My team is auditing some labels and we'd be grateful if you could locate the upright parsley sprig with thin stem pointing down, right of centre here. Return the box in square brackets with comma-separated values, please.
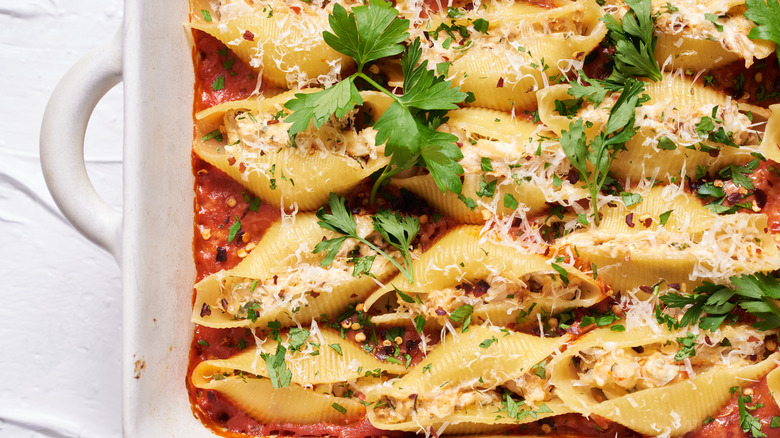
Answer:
[560, 78, 649, 225]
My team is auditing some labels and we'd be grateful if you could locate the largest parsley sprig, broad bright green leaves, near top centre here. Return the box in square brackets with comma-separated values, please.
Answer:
[285, 0, 468, 202]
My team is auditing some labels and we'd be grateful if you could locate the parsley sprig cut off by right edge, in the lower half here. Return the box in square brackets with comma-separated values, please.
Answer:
[661, 272, 780, 331]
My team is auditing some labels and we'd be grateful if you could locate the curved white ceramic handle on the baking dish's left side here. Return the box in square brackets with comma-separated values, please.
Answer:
[40, 31, 122, 257]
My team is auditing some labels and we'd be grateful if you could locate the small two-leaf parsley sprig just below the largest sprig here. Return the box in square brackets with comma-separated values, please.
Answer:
[314, 193, 420, 283]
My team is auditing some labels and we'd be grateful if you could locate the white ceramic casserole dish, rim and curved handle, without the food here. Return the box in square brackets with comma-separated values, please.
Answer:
[40, 0, 214, 438]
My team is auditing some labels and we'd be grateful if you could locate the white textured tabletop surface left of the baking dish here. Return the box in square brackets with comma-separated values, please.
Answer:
[0, 0, 122, 438]
